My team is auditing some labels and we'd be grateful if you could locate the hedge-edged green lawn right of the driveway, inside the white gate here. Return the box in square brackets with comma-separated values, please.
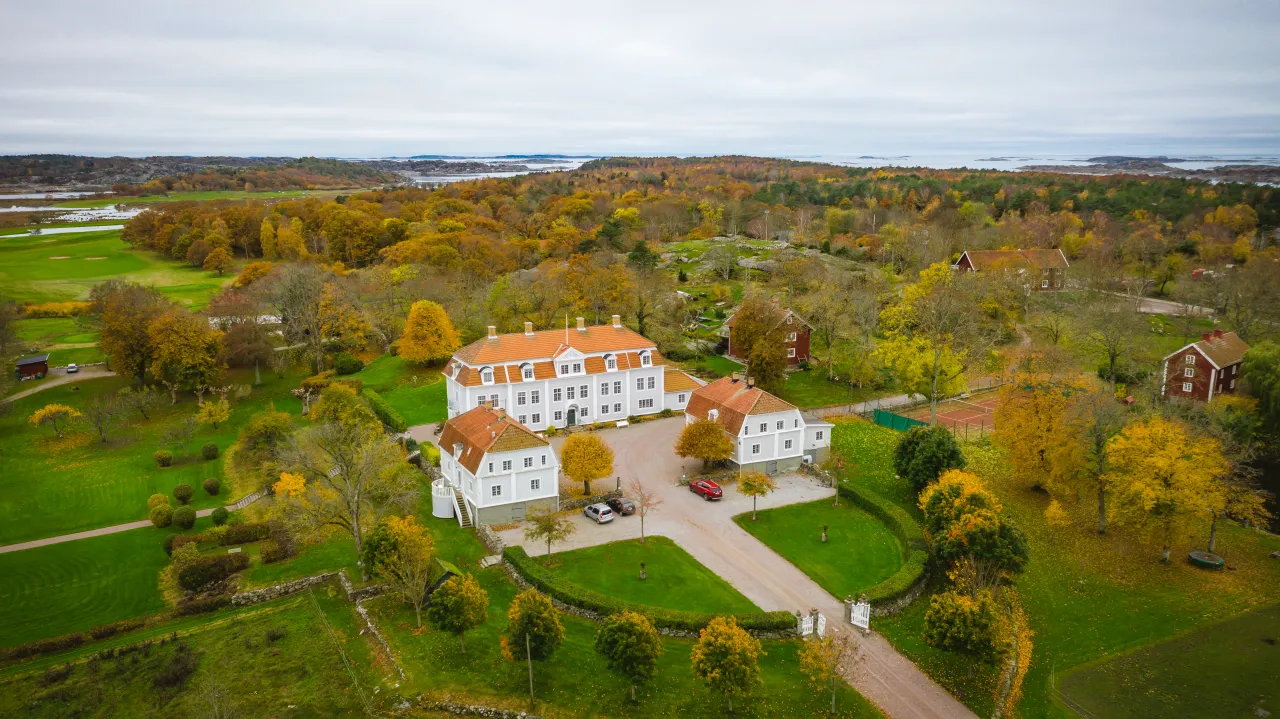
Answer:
[733, 499, 902, 597]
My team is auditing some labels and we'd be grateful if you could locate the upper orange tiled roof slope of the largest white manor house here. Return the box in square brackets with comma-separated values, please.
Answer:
[453, 325, 655, 366]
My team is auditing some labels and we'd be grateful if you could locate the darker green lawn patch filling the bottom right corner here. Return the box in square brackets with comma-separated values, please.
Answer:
[1059, 598, 1280, 719]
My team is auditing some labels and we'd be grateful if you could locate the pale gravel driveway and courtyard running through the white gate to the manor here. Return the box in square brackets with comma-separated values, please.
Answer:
[483, 417, 974, 719]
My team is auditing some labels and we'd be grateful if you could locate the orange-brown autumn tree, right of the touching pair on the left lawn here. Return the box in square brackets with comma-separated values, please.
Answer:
[147, 307, 225, 404]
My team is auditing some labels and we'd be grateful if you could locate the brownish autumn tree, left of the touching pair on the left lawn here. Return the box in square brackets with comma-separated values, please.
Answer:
[90, 280, 172, 386]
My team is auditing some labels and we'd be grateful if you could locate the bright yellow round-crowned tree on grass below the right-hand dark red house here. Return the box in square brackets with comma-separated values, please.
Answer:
[1108, 417, 1228, 564]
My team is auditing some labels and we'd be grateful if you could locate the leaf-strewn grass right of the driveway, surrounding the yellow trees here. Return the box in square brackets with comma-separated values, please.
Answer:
[833, 421, 1280, 716]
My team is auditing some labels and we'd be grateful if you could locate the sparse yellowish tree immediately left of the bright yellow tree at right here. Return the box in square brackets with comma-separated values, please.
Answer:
[1050, 391, 1125, 535]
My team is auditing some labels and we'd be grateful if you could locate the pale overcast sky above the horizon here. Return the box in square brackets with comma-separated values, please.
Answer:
[0, 0, 1280, 156]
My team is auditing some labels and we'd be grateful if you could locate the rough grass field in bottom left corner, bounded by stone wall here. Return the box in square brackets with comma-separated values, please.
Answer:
[0, 587, 379, 719]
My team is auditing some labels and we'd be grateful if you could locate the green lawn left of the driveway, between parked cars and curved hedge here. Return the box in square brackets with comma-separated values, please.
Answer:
[542, 537, 760, 614]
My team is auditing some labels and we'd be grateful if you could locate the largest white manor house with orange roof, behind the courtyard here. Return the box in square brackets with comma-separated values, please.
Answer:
[444, 315, 699, 432]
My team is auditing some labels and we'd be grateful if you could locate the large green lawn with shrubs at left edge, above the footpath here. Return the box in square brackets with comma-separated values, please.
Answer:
[0, 370, 301, 544]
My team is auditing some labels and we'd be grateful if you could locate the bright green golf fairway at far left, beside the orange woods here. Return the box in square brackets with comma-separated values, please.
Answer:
[0, 230, 232, 303]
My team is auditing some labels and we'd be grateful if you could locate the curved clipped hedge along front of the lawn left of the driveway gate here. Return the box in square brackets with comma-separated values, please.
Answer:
[503, 546, 796, 632]
